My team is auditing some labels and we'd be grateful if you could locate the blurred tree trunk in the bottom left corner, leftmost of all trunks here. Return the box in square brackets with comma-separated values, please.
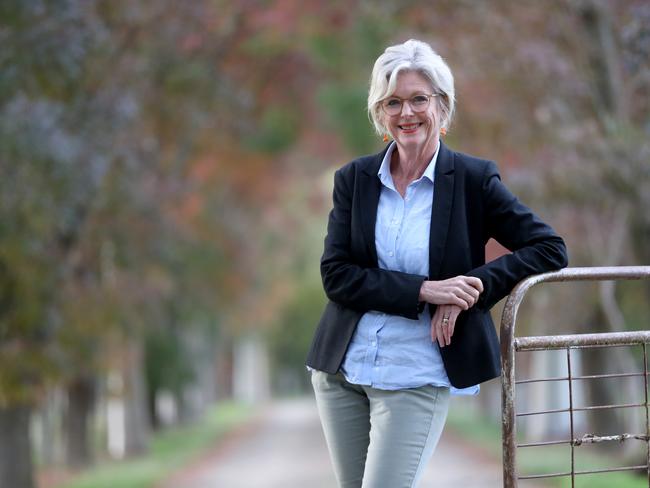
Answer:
[0, 405, 34, 488]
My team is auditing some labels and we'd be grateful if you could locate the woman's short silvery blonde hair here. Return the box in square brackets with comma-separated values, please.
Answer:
[368, 39, 456, 135]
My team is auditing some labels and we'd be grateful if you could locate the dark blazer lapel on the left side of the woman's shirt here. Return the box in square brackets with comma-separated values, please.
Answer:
[359, 144, 390, 266]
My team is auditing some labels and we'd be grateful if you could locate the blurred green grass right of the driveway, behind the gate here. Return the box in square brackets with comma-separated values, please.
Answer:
[447, 399, 648, 488]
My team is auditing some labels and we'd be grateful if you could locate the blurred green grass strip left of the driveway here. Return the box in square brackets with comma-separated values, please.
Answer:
[59, 403, 252, 488]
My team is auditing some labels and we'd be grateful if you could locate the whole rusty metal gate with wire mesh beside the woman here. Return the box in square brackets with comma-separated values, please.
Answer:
[501, 266, 650, 488]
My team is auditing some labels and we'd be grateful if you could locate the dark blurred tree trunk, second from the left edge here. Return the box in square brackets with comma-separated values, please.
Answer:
[65, 376, 95, 468]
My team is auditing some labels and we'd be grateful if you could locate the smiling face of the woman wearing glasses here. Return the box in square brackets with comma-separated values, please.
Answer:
[382, 71, 440, 151]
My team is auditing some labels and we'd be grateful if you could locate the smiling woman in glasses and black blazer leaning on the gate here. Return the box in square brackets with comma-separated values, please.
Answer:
[307, 40, 567, 488]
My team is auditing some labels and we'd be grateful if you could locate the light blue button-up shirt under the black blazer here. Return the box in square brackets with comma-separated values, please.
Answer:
[341, 143, 478, 394]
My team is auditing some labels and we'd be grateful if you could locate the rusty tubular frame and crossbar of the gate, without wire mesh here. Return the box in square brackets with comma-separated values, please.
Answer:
[500, 266, 650, 488]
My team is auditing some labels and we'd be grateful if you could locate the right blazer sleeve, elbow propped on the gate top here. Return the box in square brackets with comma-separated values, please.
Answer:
[466, 161, 568, 310]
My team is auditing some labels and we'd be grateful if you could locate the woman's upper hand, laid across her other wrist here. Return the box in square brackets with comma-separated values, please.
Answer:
[420, 275, 483, 310]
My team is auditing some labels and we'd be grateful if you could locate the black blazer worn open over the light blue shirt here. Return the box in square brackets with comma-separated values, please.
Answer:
[307, 142, 567, 388]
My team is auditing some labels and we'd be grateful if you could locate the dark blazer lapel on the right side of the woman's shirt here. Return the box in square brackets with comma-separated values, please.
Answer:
[429, 141, 454, 280]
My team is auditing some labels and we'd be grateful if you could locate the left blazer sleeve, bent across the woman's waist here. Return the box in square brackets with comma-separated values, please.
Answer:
[321, 166, 427, 319]
